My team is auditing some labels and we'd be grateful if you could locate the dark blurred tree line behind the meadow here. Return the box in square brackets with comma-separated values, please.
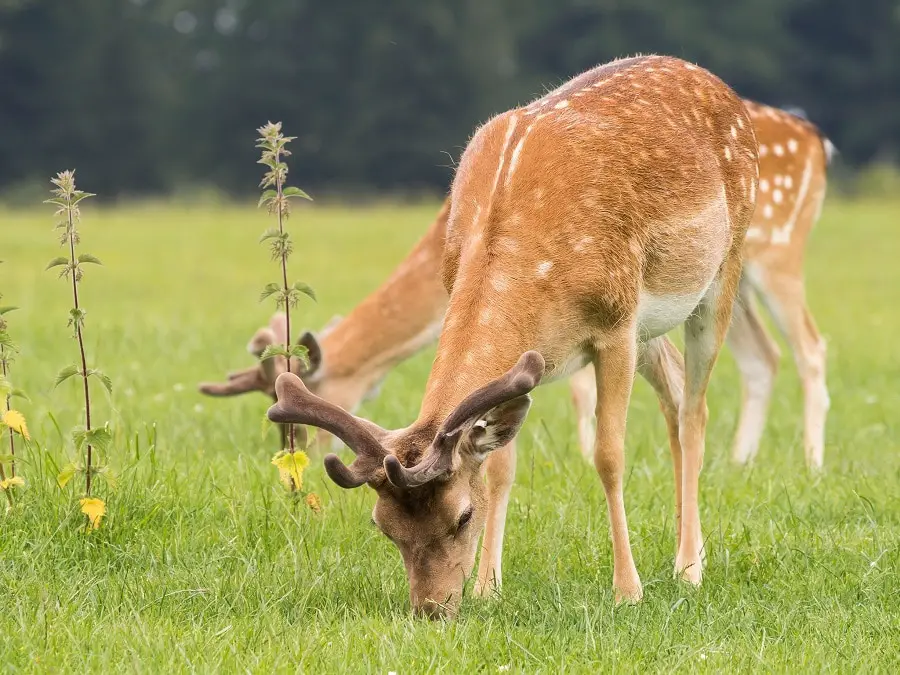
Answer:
[0, 0, 900, 195]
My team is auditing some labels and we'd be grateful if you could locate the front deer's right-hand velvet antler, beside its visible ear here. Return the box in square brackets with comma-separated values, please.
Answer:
[384, 351, 544, 489]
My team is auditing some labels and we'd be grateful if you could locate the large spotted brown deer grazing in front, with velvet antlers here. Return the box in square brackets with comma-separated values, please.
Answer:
[268, 56, 758, 616]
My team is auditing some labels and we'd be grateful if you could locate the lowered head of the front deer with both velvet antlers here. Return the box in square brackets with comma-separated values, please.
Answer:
[268, 351, 544, 617]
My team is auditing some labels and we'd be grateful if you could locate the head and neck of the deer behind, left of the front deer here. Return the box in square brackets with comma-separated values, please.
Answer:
[200, 202, 450, 447]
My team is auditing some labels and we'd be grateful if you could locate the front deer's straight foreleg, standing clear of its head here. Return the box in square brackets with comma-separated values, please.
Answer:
[594, 332, 643, 603]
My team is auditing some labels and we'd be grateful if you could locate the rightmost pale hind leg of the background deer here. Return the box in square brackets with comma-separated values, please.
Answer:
[763, 275, 829, 470]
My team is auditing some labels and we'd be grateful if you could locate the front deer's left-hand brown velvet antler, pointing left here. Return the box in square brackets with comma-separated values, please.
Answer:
[268, 373, 388, 488]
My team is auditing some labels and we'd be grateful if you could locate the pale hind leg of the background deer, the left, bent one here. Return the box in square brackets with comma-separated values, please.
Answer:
[728, 280, 781, 464]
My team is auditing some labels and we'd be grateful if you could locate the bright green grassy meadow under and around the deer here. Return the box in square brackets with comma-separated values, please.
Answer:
[0, 202, 900, 673]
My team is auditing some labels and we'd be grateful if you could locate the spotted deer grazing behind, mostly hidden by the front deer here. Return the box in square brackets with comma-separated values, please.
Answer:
[201, 100, 832, 467]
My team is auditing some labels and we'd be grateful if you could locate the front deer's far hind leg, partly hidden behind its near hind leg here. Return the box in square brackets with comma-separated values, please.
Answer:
[637, 335, 684, 552]
